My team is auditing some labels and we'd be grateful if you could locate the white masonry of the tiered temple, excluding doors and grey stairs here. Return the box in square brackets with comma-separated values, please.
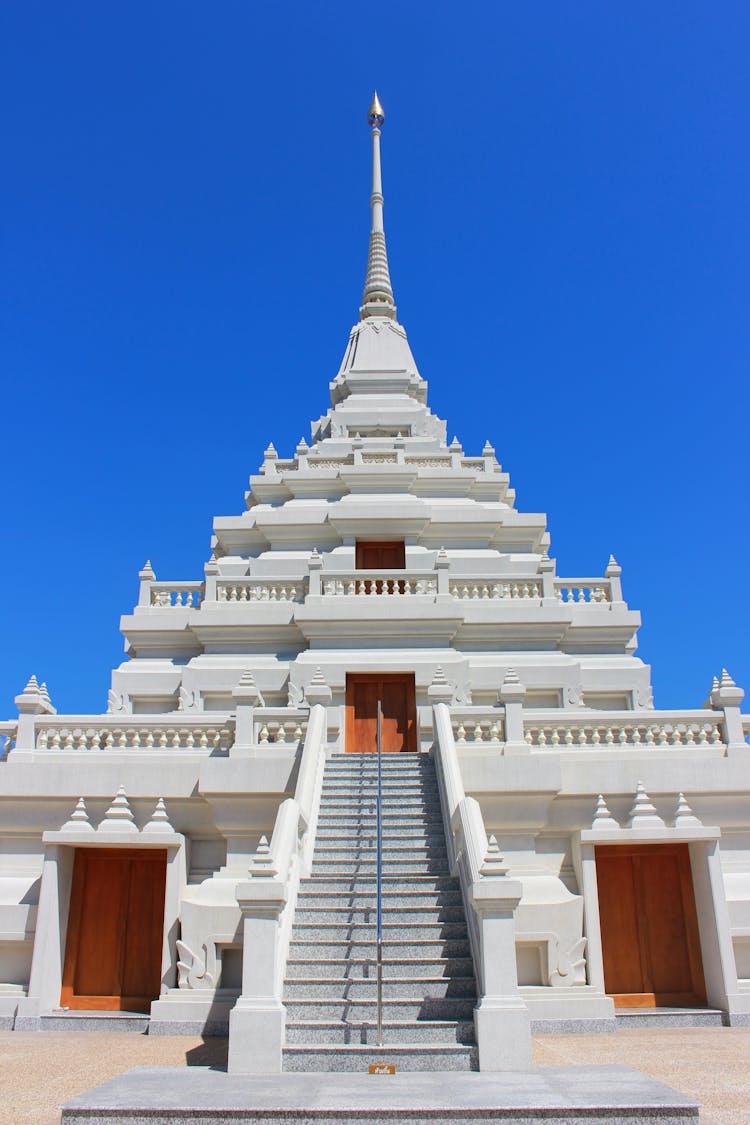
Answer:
[0, 99, 750, 1072]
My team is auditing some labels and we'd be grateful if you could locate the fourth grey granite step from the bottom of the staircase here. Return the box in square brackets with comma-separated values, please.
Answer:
[284, 977, 477, 1005]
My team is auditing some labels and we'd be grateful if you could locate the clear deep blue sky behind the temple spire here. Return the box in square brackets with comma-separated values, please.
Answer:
[0, 0, 750, 718]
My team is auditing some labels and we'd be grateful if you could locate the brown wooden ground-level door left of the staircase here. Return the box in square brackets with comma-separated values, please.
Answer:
[60, 848, 166, 1011]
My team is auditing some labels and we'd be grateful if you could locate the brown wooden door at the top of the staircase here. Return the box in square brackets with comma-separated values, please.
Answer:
[346, 672, 417, 754]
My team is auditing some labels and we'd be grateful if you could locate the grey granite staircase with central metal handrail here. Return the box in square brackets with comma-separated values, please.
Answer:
[283, 754, 477, 1071]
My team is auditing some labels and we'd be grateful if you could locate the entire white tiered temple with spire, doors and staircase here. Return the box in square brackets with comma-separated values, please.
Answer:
[0, 99, 750, 1073]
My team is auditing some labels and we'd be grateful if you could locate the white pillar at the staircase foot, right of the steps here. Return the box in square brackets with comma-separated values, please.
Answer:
[471, 875, 531, 1071]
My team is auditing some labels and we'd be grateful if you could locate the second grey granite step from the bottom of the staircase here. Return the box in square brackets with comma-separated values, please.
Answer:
[287, 1019, 476, 1046]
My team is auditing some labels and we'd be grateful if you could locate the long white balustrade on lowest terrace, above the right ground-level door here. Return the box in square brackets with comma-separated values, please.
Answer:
[523, 711, 724, 750]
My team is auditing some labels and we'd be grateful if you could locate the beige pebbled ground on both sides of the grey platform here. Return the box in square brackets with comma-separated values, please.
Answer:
[0, 1027, 750, 1125]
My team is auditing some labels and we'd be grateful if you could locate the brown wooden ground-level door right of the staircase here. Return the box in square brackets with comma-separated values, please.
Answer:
[596, 844, 706, 1008]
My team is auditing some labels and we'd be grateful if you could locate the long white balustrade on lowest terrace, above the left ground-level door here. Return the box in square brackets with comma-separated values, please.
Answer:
[36, 713, 234, 754]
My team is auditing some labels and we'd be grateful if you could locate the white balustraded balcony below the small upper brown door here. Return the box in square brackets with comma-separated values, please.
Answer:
[123, 551, 640, 655]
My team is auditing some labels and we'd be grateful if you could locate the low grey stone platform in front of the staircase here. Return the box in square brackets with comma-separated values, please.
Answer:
[62, 1067, 698, 1125]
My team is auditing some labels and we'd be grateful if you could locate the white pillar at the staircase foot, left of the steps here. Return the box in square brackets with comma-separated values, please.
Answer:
[227, 878, 287, 1074]
